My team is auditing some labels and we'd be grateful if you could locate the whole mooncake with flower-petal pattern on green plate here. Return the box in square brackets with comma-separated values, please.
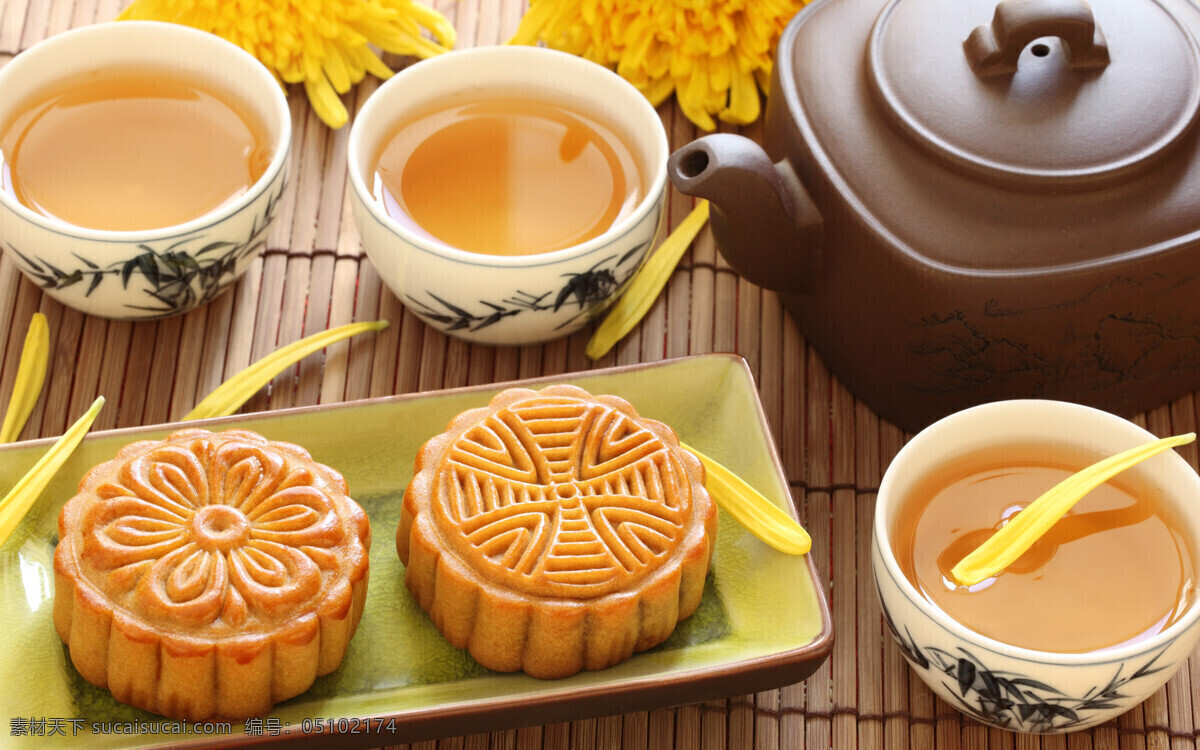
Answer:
[54, 430, 371, 721]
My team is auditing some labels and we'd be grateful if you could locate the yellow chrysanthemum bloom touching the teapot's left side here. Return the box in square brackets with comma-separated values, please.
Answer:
[510, 0, 808, 131]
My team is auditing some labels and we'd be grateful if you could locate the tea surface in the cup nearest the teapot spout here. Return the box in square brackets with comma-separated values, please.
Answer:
[373, 97, 644, 256]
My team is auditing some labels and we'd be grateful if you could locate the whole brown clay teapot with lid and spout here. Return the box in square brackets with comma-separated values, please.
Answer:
[668, 0, 1200, 430]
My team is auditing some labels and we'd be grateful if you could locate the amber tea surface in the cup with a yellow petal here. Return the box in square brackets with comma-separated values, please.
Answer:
[893, 453, 1195, 653]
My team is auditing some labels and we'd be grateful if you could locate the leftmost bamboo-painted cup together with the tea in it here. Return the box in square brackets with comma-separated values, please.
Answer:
[0, 22, 292, 319]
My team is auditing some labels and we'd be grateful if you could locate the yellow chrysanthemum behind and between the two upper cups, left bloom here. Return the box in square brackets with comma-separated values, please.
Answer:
[118, 0, 456, 128]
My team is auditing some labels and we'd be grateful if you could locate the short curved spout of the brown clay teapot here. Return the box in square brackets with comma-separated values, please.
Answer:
[667, 133, 822, 293]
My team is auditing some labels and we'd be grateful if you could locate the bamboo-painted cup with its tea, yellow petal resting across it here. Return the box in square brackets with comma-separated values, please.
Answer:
[871, 400, 1200, 733]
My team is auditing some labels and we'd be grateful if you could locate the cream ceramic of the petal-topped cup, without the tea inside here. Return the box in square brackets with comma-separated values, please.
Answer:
[871, 400, 1200, 734]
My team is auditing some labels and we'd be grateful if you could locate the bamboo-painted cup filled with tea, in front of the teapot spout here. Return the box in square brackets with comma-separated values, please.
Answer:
[349, 46, 667, 344]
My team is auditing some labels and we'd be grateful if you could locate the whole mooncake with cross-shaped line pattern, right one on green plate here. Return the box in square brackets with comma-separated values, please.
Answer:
[396, 385, 716, 678]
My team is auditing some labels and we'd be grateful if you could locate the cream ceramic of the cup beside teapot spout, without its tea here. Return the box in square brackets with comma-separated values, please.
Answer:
[349, 46, 667, 344]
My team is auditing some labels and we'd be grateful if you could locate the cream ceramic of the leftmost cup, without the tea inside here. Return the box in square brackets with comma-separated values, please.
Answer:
[0, 20, 292, 319]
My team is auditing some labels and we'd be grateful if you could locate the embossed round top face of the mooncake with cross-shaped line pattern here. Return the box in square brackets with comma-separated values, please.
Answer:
[432, 397, 691, 599]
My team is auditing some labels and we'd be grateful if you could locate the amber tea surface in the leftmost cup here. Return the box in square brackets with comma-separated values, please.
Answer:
[0, 71, 271, 232]
